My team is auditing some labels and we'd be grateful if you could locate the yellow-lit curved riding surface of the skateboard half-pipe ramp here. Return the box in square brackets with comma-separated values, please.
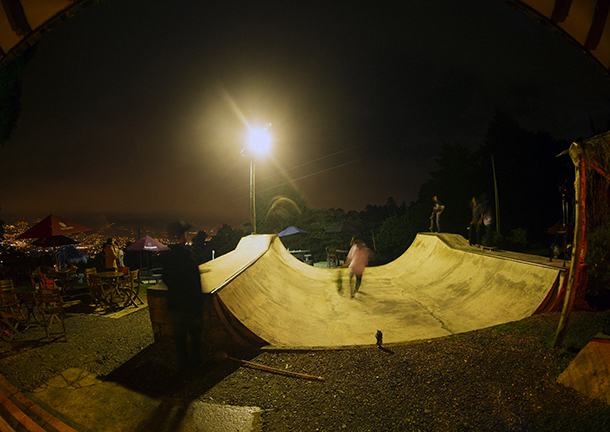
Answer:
[202, 233, 563, 347]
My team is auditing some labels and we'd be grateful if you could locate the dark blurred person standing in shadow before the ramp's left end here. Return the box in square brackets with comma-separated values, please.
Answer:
[162, 223, 203, 372]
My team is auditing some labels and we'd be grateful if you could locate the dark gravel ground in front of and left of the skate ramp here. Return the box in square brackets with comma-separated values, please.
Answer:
[0, 292, 610, 431]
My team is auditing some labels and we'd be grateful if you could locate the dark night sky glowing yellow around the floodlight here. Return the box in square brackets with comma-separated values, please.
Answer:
[0, 0, 610, 236]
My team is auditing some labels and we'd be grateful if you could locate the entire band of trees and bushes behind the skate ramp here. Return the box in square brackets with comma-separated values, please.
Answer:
[208, 112, 573, 264]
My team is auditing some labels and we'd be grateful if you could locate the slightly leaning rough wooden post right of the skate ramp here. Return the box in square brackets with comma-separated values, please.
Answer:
[553, 143, 587, 348]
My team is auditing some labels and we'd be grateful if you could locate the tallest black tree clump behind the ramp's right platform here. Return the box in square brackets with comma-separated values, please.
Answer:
[417, 111, 572, 246]
